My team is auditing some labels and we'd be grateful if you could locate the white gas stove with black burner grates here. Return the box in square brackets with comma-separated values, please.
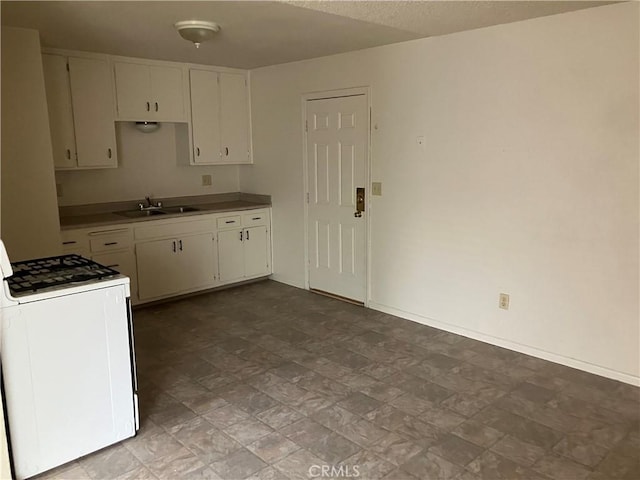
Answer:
[0, 240, 139, 480]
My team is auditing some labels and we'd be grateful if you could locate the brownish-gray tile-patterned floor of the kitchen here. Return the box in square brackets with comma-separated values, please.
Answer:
[41, 281, 640, 480]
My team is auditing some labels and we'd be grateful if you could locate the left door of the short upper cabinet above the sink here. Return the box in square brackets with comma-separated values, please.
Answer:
[114, 62, 152, 120]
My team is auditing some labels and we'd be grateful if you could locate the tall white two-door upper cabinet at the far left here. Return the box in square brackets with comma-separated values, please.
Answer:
[43, 55, 118, 169]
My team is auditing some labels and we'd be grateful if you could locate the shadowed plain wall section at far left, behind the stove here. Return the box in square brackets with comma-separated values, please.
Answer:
[0, 26, 61, 261]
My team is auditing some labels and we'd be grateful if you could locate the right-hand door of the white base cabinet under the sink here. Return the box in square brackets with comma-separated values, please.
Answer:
[178, 233, 216, 291]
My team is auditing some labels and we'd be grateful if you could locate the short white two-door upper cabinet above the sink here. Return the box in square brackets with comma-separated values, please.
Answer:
[114, 61, 186, 122]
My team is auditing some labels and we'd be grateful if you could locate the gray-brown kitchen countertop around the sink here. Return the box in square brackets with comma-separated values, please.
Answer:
[60, 193, 271, 230]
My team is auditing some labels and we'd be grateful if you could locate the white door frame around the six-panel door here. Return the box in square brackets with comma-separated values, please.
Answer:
[300, 86, 372, 307]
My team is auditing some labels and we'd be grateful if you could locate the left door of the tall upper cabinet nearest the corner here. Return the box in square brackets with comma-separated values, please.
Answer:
[189, 70, 221, 164]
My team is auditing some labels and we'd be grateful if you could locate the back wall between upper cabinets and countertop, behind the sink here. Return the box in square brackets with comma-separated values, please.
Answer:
[56, 122, 240, 206]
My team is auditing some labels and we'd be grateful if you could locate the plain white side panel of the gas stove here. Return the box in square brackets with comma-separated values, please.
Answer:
[2, 285, 136, 479]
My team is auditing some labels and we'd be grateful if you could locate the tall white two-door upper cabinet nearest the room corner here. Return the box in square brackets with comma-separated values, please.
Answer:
[189, 69, 252, 165]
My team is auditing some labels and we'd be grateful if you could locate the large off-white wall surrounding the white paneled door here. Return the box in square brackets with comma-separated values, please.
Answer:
[240, 2, 640, 383]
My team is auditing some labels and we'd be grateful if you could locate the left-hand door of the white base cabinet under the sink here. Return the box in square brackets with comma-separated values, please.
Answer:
[136, 239, 181, 300]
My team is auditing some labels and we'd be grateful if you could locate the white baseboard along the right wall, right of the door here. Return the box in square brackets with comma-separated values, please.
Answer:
[368, 301, 640, 386]
